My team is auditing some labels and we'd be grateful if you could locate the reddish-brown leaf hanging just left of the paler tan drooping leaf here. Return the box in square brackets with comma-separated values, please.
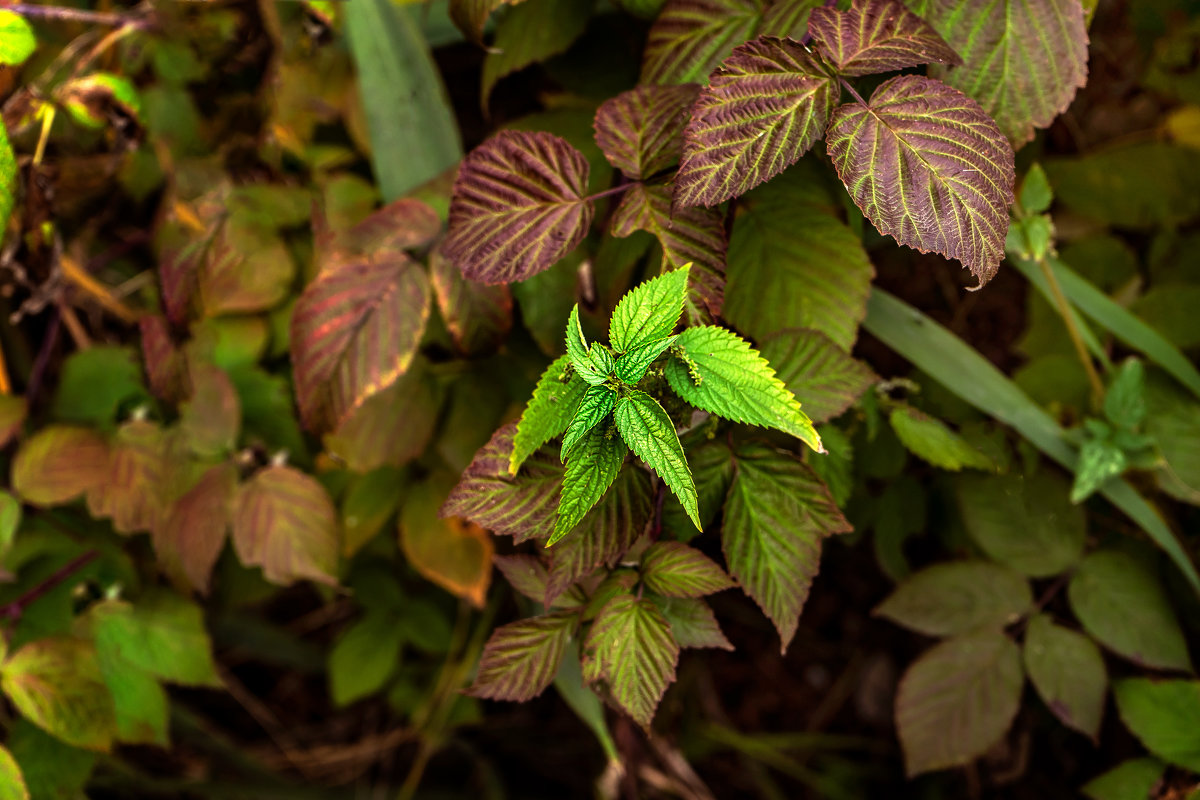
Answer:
[154, 463, 238, 594]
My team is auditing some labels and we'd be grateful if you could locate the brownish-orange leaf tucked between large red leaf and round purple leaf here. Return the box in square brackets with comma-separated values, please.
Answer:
[430, 251, 512, 355]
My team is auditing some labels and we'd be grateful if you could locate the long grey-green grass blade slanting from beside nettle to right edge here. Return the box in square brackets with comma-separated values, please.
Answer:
[863, 287, 1200, 594]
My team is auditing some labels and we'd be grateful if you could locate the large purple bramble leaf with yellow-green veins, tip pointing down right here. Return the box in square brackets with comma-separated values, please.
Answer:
[826, 76, 1015, 285]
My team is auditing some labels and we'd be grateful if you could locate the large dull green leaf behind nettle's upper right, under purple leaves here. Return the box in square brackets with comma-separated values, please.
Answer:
[722, 160, 875, 353]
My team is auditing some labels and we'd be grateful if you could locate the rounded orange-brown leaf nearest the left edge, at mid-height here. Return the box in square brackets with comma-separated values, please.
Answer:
[12, 425, 108, 506]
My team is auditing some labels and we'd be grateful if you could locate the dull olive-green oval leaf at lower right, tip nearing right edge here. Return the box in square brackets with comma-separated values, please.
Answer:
[1067, 551, 1192, 670]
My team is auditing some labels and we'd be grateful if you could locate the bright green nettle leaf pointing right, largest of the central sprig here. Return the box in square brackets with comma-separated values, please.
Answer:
[666, 325, 822, 452]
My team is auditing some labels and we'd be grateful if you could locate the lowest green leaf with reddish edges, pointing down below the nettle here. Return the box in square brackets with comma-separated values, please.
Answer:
[583, 594, 679, 729]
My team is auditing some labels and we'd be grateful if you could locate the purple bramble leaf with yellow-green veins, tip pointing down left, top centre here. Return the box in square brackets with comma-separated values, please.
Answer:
[674, 36, 839, 206]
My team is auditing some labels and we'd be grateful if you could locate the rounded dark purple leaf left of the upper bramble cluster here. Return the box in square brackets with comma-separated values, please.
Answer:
[443, 131, 593, 283]
